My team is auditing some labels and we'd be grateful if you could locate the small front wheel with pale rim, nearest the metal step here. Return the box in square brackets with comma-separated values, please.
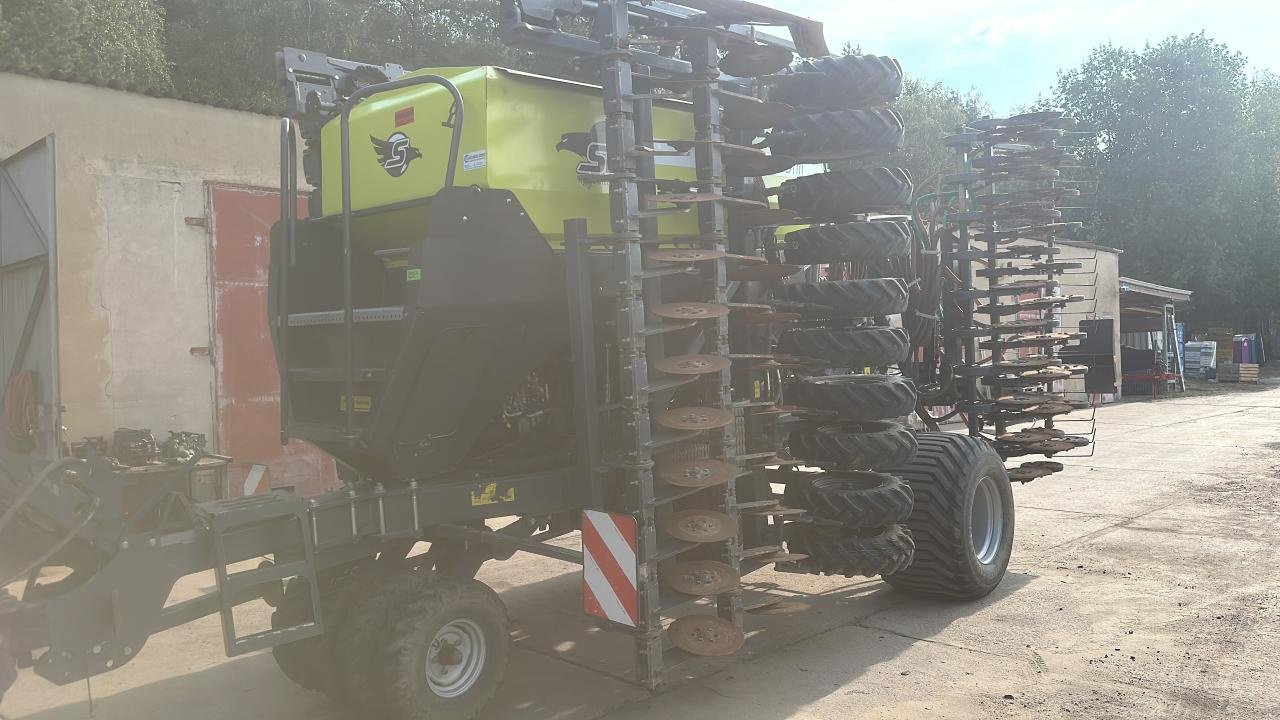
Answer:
[335, 570, 511, 720]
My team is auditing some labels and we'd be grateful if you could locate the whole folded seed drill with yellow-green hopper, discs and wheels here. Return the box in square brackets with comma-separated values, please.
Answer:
[0, 0, 1100, 719]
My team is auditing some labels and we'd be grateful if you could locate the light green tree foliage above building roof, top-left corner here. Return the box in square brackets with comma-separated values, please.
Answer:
[0, 0, 170, 90]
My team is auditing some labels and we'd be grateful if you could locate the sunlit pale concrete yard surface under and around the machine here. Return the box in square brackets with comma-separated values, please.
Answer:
[0, 388, 1280, 720]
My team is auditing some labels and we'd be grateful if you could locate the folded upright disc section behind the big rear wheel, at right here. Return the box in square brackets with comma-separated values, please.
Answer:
[943, 110, 1092, 483]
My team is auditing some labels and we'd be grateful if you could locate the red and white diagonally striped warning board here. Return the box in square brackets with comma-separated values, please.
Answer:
[582, 510, 640, 628]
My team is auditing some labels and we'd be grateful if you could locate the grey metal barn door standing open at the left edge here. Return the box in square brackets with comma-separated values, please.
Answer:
[0, 135, 61, 459]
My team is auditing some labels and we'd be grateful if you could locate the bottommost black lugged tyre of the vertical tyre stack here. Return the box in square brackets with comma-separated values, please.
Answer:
[783, 523, 915, 578]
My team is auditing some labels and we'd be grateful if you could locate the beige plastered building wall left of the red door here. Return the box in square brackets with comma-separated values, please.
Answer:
[0, 73, 279, 439]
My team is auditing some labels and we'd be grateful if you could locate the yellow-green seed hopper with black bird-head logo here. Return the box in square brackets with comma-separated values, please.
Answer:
[320, 67, 698, 246]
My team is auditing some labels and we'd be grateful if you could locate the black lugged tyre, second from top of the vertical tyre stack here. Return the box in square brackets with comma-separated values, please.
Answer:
[768, 108, 905, 161]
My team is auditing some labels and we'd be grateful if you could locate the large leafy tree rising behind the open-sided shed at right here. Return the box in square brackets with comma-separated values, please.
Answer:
[1053, 33, 1280, 325]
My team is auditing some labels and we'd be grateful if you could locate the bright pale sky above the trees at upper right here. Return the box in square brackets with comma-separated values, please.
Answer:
[758, 0, 1280, 114]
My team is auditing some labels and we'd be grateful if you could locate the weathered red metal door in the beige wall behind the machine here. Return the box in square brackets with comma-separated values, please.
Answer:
[209, 184, 337, 495]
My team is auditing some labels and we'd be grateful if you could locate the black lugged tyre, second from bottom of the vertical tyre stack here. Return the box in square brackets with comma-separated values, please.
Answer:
[782, 470, 911, 528]
